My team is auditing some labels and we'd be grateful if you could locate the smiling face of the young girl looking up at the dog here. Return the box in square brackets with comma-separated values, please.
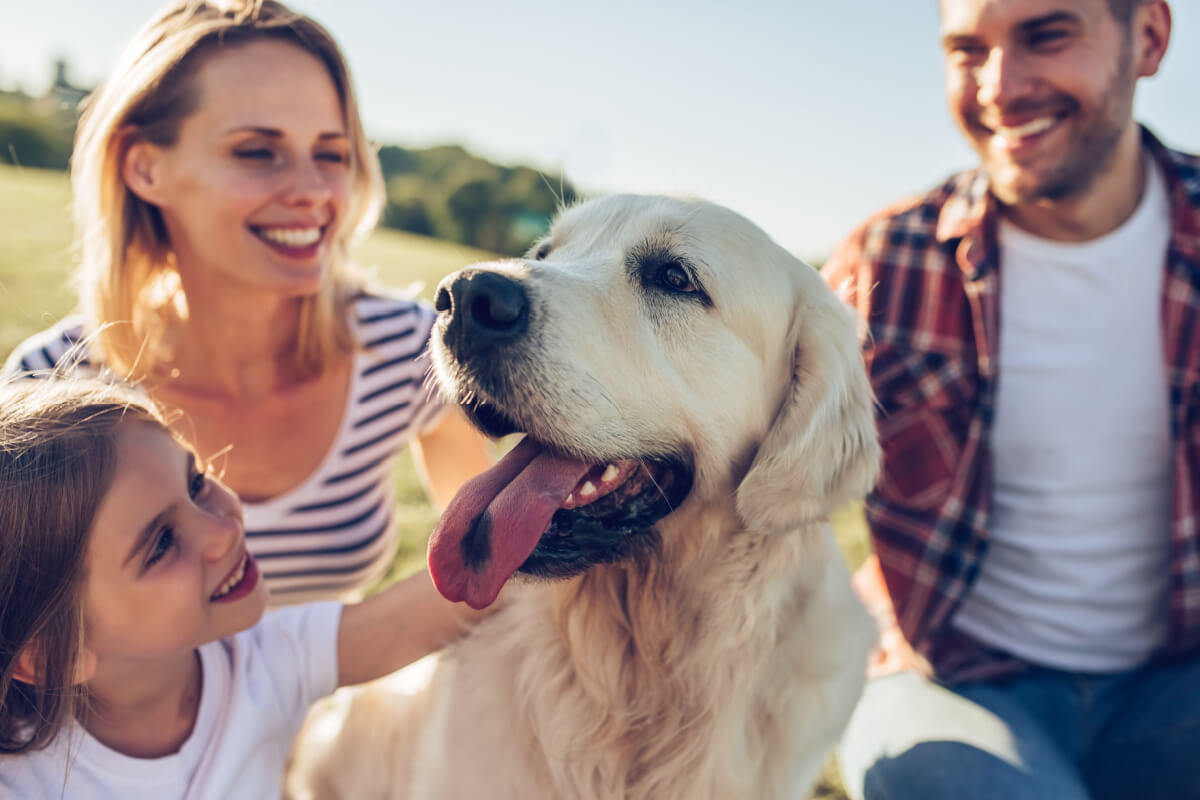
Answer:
[84, 421, 266, 664]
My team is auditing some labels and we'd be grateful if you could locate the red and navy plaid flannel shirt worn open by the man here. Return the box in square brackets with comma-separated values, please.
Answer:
[823, 130, 1200, 682]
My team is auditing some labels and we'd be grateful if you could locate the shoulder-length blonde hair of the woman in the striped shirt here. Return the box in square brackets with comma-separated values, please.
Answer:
[71, 0, 384, 378]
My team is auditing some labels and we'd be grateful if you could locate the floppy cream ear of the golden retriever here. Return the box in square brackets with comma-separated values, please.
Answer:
[737, 284, 881, 533]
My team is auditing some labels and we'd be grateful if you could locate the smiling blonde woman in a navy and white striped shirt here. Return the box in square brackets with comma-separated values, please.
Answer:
[7, 0, 491, 599]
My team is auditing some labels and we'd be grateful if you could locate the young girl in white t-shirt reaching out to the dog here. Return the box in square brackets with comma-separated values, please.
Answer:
[0, 379, 482, 800]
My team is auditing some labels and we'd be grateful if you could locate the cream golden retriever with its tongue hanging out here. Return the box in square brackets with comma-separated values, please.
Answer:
[289, 196, 878, 800]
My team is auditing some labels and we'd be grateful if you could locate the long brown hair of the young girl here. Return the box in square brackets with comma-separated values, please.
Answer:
[0, 377, 167, 753]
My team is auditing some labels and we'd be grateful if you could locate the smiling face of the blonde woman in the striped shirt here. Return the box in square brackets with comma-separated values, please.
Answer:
[133, 40, 354, 299]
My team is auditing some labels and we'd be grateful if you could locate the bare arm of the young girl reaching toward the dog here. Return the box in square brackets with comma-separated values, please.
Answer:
[337, 570, 494, 686]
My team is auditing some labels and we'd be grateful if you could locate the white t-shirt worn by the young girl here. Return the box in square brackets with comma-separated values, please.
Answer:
[0, 602, 342, 800]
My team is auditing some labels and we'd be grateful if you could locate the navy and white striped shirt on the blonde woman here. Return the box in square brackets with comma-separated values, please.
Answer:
[5, 294, 444, 603]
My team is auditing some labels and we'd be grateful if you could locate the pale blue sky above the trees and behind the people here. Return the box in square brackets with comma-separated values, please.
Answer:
[0, 0, 1200, 260]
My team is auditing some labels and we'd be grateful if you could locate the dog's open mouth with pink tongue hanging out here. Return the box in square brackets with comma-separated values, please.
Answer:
[428, 404, 692, 608]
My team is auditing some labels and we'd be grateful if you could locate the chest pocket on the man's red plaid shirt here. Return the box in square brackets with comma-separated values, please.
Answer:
[871, 344, 978, 511]
